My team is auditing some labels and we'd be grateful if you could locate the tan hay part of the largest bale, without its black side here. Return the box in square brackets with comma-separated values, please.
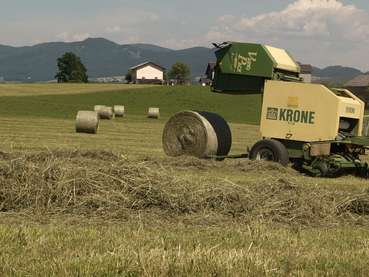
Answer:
[162, 111, 218, 158]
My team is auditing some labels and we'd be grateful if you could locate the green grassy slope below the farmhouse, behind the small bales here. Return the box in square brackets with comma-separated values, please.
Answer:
[0, 84, 261, 124]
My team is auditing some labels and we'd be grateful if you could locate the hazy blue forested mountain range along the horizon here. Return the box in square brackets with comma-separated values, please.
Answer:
[0, 38, 362, 82]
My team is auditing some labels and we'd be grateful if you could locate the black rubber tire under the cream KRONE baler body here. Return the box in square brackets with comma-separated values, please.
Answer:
[249, 139, 290, 166]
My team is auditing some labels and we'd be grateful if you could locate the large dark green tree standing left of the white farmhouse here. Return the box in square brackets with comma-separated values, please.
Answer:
[55, 52, 88, 83]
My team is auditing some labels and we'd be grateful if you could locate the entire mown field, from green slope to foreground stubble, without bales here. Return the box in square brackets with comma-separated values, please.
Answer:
[0, 84, 369, 276]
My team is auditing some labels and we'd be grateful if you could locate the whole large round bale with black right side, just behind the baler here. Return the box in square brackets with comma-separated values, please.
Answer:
[162, 111, 232, 158]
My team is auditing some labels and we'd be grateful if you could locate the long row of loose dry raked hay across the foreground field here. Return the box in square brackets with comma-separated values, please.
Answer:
[0, 151, 369, 226]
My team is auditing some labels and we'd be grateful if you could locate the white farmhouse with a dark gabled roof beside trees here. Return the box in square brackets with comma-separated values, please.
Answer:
[130, 62, 165, 84]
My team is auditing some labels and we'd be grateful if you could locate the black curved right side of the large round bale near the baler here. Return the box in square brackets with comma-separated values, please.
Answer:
[198, 112, 232, 156]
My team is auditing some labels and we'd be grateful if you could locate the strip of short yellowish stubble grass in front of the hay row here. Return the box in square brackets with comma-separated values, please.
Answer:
[0, 220, 369, 276]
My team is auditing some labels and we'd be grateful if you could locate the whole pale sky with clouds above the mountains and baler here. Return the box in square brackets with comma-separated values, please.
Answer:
[0, 0, 369, 71]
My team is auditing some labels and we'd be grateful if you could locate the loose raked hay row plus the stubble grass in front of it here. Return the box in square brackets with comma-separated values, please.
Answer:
[0, 151, 369, 276]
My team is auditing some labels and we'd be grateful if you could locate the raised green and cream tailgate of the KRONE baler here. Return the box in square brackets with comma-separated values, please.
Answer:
[212, 42, 301, 93]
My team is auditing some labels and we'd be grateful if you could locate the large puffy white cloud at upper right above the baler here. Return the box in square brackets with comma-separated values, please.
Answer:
[209, 0, 369, 41]
